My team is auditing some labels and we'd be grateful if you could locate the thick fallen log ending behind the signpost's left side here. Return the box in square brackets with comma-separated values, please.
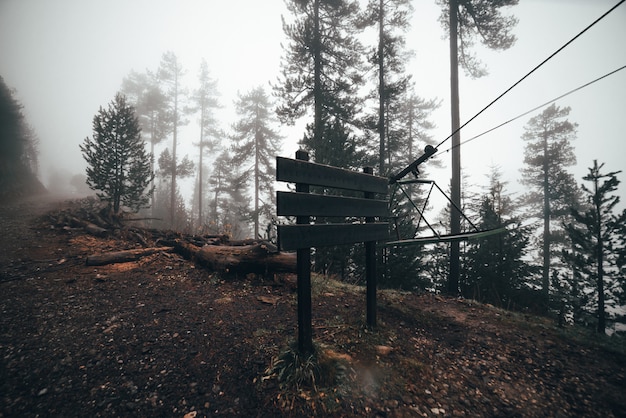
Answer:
[174, 240, 297, 274]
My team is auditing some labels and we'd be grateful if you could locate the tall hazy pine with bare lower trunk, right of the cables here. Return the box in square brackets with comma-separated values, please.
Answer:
[521, 104, 577, 309]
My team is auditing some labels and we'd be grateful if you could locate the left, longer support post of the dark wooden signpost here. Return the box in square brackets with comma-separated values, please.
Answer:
[296, 151, 313, 354]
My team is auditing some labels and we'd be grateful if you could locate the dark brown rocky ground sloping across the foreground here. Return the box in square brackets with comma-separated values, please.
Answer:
[0, 200, 626, 418]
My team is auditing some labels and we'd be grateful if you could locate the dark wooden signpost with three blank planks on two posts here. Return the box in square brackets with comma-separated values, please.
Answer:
[276, 151, 389, 353]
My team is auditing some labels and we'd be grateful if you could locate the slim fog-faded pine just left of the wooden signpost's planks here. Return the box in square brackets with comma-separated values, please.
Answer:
[232, 87, 280, 238]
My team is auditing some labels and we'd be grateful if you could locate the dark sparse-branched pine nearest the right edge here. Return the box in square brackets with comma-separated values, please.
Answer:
[564, 160, 626, 334]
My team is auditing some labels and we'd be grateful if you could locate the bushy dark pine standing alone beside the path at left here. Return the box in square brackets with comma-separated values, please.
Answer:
[80, 93, 154, 213]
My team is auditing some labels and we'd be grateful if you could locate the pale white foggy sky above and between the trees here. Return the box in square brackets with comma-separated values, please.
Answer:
[0, 0, 626, 207]
